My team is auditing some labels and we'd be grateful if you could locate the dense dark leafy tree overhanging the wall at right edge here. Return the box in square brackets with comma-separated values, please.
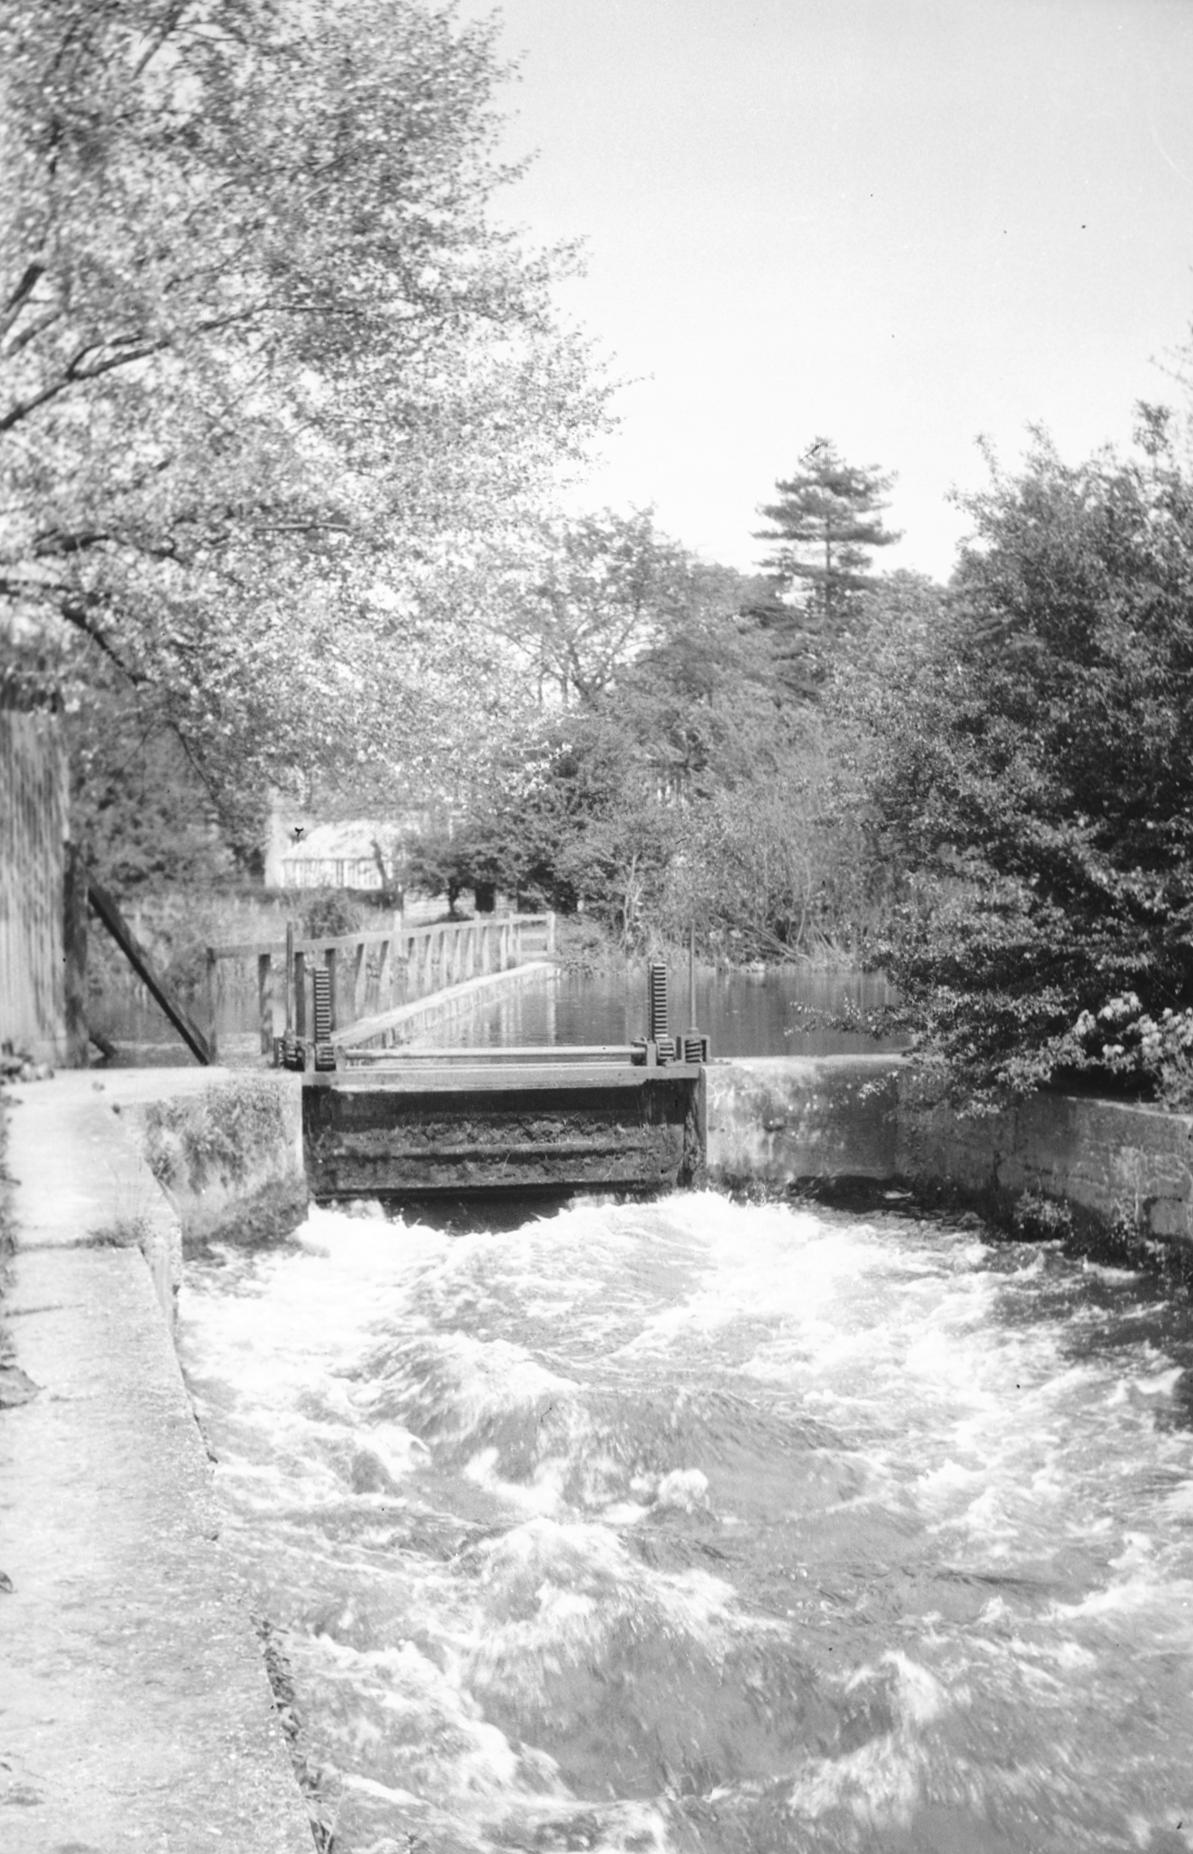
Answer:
[857, 408, 1193, 1096]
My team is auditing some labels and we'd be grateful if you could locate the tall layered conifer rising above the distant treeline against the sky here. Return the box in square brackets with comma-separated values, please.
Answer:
[755, 438, 900, 695]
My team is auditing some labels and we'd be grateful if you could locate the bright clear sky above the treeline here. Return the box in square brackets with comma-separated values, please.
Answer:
[460, 0, 1193, 578]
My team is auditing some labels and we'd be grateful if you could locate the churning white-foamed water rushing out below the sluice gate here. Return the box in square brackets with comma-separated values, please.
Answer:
[184, 1194, 1193, 1854]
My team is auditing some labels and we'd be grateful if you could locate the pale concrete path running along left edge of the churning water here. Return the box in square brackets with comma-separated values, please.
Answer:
[0, 1068, 314, 1854]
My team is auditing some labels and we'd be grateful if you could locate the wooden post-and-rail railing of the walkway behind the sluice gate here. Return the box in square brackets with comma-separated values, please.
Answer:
[206, 914, 555, 1060]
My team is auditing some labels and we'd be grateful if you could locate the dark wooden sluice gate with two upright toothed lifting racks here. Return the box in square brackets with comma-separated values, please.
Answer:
[280, 964, 709, 1201]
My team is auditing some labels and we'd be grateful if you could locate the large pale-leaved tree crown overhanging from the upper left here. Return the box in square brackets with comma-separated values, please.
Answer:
[0, 0, 605, 815]
